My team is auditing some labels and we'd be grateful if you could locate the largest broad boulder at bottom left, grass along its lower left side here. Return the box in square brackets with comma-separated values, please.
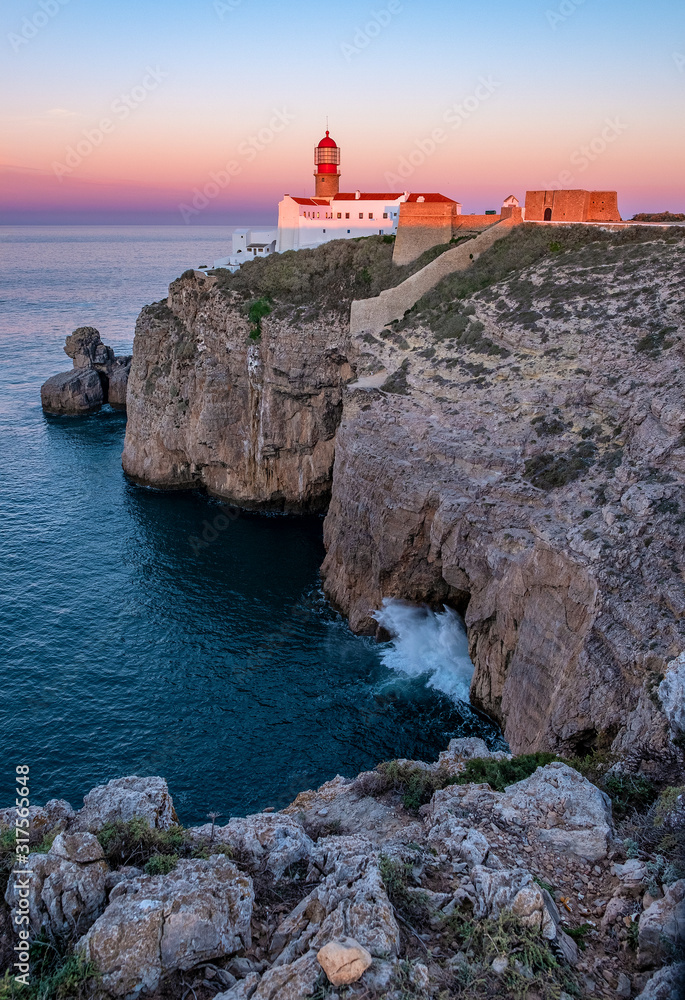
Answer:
[77, 854, 254, 997]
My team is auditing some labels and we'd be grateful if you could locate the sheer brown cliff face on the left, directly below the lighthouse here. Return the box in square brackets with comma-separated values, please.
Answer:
[123, 275, 351, 510]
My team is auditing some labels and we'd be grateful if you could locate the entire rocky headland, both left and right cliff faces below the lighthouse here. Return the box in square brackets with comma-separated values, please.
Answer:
[124, 227, 685, 751]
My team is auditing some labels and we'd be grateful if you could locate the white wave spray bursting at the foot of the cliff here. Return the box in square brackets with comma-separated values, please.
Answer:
[374, 597, 473, 702]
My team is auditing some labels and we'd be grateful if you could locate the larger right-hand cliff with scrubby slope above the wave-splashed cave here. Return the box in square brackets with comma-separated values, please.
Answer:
[323, 236, 685, 750]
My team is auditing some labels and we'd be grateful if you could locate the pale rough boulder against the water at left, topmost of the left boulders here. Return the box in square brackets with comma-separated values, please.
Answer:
[74, 775, 177, 833]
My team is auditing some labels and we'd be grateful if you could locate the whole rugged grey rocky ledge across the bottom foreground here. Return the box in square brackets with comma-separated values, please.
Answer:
[0, 739, 685, 1000]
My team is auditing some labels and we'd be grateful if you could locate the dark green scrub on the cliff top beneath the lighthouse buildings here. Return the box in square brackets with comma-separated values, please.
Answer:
[211, 236, 471, 318]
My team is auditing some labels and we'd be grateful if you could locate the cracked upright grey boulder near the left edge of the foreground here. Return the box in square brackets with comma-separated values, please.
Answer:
[5, 833, 109, 944]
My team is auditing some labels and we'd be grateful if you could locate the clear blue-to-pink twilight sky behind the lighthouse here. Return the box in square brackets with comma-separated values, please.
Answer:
[0, 0, 685, 225]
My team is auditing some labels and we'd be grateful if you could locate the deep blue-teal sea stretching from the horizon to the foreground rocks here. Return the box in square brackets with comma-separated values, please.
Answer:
[0, 227, 498, 823]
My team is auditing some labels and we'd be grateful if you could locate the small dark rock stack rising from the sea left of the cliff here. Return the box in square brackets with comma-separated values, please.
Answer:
[40, 326, 131, 415]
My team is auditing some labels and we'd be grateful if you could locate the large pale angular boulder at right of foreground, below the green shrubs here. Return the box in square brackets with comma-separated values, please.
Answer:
[494, 761, 611, 861]
